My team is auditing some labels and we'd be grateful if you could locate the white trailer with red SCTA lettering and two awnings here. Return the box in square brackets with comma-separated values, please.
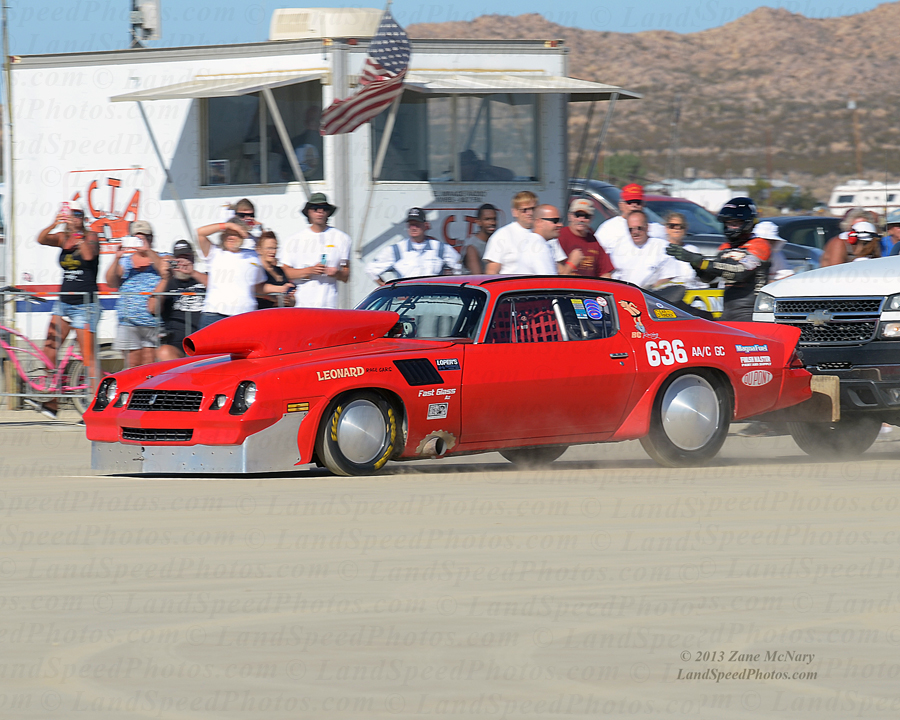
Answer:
[4, 24, 639, 337]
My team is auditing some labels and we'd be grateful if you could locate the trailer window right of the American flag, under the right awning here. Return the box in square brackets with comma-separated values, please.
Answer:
[372, 91, 538, 183]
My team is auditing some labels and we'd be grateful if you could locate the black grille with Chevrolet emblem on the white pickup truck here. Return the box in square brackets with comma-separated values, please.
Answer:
[775, 296, 884, 345]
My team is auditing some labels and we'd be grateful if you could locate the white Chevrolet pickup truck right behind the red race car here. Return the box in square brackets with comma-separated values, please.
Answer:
[753, 257, 900, 457]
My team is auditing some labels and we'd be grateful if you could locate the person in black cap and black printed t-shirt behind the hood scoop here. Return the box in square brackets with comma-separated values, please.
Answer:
[147, 240, 207, 360]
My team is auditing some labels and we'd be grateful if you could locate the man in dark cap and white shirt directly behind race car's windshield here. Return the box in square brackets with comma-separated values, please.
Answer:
[366, 208, 462, 285]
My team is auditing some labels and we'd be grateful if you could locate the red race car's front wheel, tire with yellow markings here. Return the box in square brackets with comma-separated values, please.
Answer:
[316, 390, 400, 476]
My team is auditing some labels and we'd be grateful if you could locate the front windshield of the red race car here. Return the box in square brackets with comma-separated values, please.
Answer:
[357, 285, 487, 339]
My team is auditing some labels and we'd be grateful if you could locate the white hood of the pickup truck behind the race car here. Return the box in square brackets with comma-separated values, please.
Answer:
[762, 256, 900, 298]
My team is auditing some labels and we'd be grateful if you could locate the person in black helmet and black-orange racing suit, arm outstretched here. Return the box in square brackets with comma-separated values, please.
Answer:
[666, 197, 772, 322]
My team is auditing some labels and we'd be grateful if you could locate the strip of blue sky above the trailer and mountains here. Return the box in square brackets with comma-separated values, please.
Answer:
[7, 0, 880, 55]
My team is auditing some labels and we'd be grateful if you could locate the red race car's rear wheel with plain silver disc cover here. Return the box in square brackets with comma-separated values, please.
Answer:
[641, 370, 734, 467]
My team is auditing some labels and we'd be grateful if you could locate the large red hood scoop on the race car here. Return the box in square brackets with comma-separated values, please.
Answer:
[184, 308, 400, 358]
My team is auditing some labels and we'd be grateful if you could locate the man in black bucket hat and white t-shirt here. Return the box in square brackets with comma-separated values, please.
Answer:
[278, 193, 350, 308]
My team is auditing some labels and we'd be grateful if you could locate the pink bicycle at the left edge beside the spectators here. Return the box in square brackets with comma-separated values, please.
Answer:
[0, 293, 91, 414]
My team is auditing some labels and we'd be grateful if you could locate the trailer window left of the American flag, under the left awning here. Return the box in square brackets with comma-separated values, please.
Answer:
[203, 81, 324, 185]
